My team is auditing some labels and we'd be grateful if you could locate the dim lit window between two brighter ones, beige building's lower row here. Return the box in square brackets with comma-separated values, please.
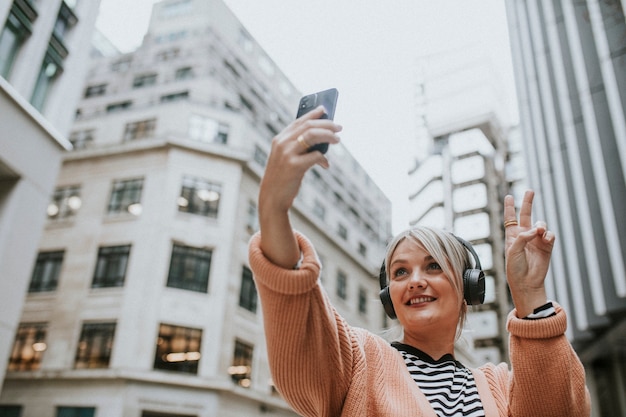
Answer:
[74, 322, 115, 369]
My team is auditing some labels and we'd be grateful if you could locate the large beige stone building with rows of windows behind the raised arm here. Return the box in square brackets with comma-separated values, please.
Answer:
[0, 0, 391, 417]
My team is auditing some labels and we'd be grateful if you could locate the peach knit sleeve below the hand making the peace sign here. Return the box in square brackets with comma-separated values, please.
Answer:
[507, 303, 591, 417]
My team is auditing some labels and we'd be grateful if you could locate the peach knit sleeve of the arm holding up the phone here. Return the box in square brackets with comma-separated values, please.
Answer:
[249, 232, 357, 416]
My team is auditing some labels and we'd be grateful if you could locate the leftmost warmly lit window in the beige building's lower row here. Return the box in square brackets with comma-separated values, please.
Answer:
[7, 323, 48, 371]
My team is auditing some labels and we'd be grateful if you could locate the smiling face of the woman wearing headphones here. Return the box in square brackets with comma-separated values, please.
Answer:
[388, 237, 463, 338]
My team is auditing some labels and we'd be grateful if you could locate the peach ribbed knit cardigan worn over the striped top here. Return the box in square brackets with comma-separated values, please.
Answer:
[249, 232, 590, 417]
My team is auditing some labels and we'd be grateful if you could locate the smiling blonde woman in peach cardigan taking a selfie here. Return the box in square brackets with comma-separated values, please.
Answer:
[250, 108, 590, 417]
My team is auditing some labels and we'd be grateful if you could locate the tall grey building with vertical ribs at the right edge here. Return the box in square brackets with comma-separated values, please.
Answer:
[507, 0, 626, 416]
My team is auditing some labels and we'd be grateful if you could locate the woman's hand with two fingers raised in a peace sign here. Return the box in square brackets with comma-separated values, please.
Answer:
[504, 191, 555, 318]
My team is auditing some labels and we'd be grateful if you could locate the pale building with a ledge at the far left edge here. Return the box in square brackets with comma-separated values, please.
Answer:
[0, 0, 100, 389]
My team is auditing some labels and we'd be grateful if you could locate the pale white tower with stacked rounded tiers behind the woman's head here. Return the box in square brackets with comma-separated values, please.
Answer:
[409, 47, 523, 365]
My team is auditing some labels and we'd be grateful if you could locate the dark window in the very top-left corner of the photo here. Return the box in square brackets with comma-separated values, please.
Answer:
[0, 1, 37, 79]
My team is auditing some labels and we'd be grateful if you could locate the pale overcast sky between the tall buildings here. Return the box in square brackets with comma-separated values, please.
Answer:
[96, 0, 516, 233]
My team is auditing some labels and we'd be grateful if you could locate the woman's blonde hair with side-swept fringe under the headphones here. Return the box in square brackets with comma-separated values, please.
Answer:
[385, 226, 472, 339]
